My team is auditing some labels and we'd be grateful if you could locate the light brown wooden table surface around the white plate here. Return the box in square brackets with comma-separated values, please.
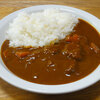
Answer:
[0, 0, 100, 100]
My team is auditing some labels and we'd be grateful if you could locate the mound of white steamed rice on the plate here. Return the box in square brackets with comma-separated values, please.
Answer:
[7, 8, 78, 47]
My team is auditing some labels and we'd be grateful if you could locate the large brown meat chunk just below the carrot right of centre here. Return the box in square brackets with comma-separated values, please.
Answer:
[62, 43, 81, 59]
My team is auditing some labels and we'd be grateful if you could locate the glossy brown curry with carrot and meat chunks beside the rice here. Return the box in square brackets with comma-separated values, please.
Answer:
[1, 19, 100, 85]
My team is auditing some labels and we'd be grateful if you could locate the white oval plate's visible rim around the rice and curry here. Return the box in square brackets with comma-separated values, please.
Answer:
[0, 5, 100, 94]
